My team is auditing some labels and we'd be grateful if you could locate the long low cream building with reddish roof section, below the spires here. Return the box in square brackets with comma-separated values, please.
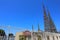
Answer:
[15, 31, 60, 40]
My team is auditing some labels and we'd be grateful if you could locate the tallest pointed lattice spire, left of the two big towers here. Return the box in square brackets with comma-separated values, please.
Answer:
[43, 4, 50, 32]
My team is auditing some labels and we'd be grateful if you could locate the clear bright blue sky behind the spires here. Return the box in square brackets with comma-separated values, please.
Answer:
[0, 0, 60, 33]
